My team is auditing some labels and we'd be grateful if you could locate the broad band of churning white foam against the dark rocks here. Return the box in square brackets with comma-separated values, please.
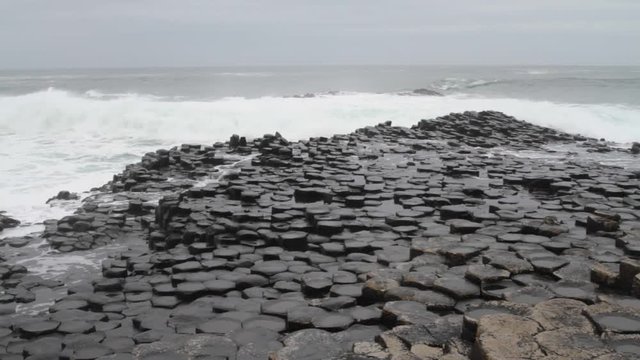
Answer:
[0, 89, 640, 232]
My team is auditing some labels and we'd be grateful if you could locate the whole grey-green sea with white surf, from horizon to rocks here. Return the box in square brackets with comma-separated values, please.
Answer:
[0, 66, 640, 237]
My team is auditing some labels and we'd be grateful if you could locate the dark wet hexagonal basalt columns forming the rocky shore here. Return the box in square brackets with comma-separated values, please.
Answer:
[0, 111, 640, 360]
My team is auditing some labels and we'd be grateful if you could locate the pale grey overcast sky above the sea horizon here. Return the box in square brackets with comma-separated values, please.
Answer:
[0, 0, 640, 68]
